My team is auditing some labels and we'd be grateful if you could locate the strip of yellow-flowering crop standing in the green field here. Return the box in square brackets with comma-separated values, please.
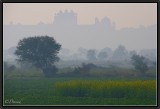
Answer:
[55, 80, 156, 99]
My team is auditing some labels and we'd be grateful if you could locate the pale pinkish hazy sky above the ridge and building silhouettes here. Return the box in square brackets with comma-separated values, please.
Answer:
[3, 3, 157, 29]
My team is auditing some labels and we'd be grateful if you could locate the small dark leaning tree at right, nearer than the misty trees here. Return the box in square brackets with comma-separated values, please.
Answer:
[131, 55, 148, 74]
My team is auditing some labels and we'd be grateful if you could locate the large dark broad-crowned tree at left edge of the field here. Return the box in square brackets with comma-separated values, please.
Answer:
[15, 36, 61, 77]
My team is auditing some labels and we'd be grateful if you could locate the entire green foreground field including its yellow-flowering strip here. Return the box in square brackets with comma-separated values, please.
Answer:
[3, 77, 156, 106]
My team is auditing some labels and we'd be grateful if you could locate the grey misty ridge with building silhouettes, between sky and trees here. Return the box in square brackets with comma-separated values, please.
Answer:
[3, 10, 157, 65]
